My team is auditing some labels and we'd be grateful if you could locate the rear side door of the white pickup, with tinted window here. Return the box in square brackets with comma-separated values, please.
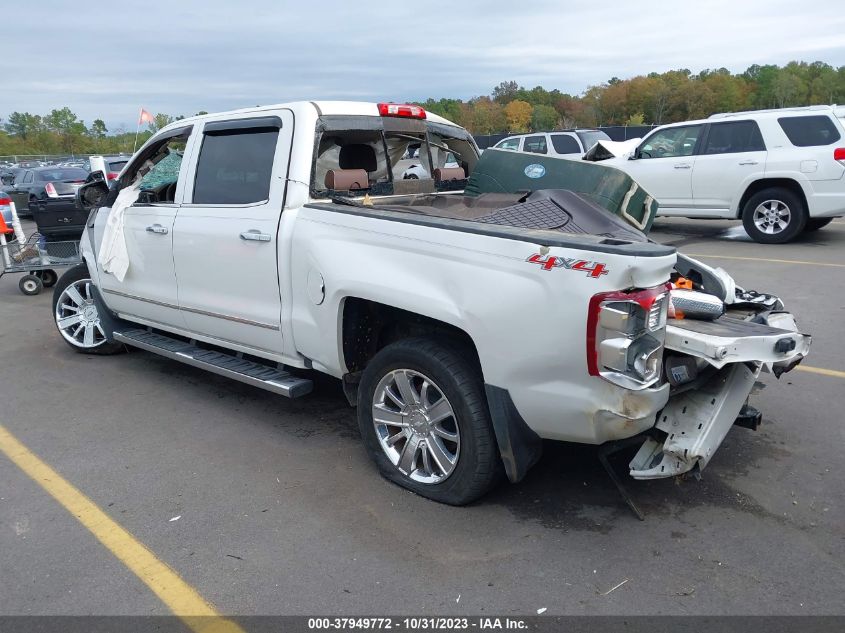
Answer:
[173, 110, 293, 358]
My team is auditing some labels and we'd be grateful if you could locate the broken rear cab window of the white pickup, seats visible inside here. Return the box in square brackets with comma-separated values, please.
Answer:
[311, 115, 478, 198]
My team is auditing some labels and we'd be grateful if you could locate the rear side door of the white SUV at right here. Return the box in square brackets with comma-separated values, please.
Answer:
[692, 121, 766, 217]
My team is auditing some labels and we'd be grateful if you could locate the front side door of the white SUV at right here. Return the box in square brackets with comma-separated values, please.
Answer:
[620, 125, 703, 215]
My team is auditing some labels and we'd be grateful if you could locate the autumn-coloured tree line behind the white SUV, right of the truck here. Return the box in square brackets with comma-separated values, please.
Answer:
[419, 62, 845, 134]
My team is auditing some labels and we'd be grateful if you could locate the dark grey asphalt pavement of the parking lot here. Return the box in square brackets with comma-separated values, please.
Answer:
[0, 219, 845, 615]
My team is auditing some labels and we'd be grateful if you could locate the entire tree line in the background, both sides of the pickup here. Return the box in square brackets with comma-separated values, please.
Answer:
[0, 61, 845, 155]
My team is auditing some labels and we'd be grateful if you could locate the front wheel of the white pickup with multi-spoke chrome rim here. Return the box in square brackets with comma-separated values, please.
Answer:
[51, 264, 126, 355]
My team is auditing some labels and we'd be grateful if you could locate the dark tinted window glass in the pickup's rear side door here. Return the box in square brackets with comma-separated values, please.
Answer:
[193, 128, 279, 204]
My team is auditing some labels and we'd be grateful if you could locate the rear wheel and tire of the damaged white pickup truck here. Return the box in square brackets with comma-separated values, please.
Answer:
[358, 338, 504, 505]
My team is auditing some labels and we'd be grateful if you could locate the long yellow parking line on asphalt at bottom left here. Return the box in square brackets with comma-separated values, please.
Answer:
[0, 425, 243, 633]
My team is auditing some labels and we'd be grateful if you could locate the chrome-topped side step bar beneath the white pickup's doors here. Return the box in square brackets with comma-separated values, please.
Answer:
[114, 329, 314, 398]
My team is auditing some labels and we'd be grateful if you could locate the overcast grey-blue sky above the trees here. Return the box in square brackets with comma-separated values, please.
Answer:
[0, 0, 845, 130]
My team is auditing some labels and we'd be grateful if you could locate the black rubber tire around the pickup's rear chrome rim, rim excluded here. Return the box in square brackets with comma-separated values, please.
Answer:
[358, 338, 502, 505]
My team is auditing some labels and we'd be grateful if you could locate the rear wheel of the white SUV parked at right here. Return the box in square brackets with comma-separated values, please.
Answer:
[742, 187, 807, 244]
